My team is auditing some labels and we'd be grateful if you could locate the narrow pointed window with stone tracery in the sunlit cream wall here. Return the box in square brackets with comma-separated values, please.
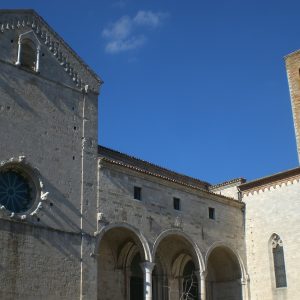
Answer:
[271, 234, 287, 288]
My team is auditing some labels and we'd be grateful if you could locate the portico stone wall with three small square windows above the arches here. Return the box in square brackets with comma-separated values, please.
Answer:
[97, 161, 246, 300]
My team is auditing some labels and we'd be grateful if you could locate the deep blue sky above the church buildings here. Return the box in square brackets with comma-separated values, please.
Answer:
[2, 0, 300, 183]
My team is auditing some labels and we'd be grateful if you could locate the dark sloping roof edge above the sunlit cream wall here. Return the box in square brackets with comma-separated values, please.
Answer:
[239, 167, 300, 191]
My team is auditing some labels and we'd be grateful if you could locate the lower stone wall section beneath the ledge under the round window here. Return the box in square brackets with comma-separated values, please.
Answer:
[0, 219, 81, 300]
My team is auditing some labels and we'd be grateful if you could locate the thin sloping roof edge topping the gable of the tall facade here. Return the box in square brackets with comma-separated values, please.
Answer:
[0, 9, 104, 86]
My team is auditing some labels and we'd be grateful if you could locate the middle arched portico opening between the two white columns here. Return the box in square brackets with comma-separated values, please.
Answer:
[153, 234, 200, 300]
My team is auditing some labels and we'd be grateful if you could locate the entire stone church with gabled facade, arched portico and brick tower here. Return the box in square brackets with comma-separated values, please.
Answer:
[0, 10, 300, 300]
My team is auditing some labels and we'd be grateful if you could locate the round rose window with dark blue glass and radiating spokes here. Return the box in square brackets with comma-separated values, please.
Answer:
[0, 165, 36, 213]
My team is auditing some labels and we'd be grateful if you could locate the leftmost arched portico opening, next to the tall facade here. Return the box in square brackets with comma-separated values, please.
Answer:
[97, 227, 147, 300]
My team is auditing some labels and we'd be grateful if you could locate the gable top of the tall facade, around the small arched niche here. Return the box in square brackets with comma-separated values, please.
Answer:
[0, 10, 102, 92]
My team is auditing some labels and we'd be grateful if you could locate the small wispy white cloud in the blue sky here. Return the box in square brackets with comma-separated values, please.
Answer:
[102, 10, 168, 54]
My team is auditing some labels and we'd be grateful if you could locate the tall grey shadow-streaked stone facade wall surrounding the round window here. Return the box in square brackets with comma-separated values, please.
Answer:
[0, 11, 98, 300]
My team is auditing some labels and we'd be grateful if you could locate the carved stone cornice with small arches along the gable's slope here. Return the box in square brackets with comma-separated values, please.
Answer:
[0, 9, 103, 93]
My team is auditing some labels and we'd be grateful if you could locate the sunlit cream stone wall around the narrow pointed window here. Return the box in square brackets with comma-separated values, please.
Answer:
[243, 178, 300, 300]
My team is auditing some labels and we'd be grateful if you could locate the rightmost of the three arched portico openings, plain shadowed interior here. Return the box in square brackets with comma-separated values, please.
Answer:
[206, 246, 242, 300]
